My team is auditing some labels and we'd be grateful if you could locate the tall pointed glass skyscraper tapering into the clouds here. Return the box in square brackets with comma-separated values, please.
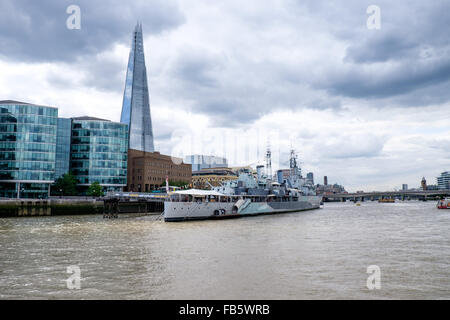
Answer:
[120, 23, 155, 152]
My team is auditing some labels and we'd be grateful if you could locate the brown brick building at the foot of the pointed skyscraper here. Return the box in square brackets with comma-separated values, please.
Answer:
[126, 149, 192, 192]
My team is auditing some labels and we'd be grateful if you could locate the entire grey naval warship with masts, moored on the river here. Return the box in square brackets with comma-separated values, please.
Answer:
[164, 150, 322, 222]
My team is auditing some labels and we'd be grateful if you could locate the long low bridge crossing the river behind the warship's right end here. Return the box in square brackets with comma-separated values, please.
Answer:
[323, 189, 450, 201]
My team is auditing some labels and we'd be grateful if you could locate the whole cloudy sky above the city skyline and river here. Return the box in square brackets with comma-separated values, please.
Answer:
[0, 0, 450, 191]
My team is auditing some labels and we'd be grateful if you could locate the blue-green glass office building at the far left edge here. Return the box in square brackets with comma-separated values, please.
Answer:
[0, 100, 58, 198]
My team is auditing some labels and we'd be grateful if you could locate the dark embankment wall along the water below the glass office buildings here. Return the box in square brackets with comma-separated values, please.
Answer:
[0, 199, 104, 218]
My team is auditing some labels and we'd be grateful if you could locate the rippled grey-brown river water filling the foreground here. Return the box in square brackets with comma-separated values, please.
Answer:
[0, 201, 450, 299]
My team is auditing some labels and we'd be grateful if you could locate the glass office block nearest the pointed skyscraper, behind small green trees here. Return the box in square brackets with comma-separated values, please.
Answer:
[70, 117, 128, 192]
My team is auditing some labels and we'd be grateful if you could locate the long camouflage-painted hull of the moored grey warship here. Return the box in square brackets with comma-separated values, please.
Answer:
[164, 196, 321, 222]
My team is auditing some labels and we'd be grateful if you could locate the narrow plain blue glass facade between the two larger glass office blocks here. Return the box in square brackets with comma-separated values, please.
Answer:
[55, 118, 72, 180]
